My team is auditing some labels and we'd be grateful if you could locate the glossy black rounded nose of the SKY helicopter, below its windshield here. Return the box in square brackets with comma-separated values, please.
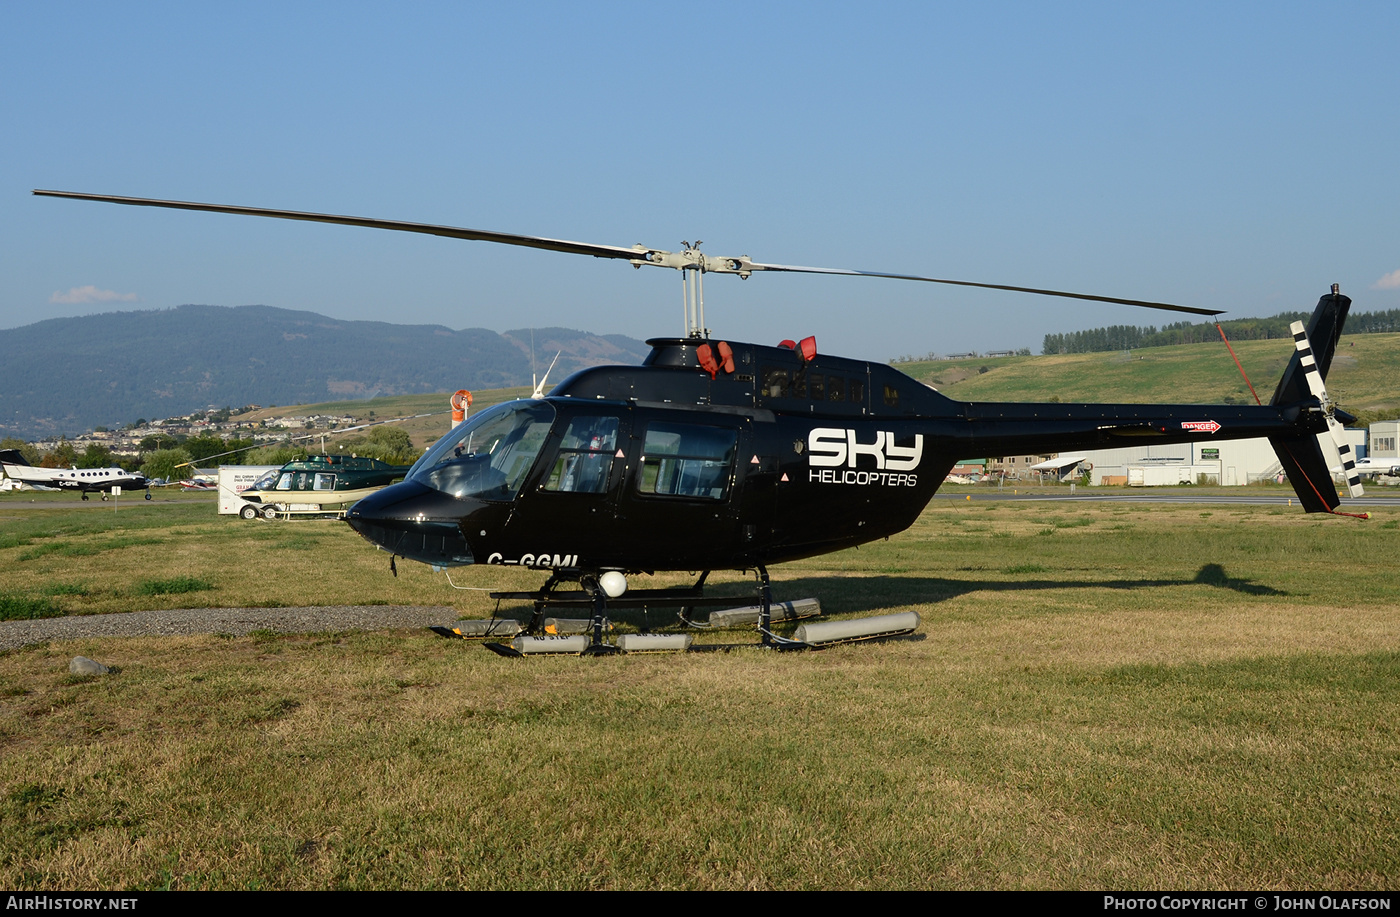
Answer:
[346, 482, 475, 567]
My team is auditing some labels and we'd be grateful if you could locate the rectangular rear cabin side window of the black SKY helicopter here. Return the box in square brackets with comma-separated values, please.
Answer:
[637, 423, 739, 500]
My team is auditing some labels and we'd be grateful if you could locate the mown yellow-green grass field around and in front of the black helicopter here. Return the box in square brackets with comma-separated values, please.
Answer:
[0, 500, 1400, 889]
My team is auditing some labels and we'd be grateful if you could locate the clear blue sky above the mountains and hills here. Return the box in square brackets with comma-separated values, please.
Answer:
[0, 3, 1400, 360]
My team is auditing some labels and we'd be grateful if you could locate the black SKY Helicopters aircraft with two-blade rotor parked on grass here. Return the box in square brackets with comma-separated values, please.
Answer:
[34, 190, 1359, 654]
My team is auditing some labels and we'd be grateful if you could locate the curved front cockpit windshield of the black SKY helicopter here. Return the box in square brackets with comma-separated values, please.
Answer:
[407, 400, 554, 500]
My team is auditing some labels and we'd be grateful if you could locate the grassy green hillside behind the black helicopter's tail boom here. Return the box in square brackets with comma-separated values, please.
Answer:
[896, 333, 1400, 421]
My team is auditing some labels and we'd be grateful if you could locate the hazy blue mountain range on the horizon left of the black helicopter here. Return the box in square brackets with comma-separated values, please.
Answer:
[0, 305, 650, 440]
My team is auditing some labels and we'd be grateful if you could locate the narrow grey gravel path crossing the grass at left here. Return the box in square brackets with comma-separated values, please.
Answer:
[0, 605, 458, 650]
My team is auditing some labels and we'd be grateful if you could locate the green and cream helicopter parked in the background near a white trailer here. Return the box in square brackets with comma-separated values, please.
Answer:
[238, 455, 410, 519]
